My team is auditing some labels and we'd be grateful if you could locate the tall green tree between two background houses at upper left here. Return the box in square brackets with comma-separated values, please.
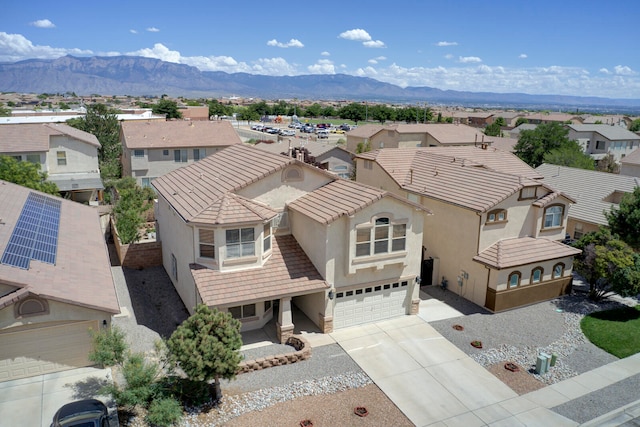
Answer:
[67, 103, 122, 179]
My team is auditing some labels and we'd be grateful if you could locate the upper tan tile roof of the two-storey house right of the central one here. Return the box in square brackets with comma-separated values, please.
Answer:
[358, 147, 553, 212]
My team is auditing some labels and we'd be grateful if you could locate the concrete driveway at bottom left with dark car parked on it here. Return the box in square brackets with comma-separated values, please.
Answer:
[0, 368, 118, 427]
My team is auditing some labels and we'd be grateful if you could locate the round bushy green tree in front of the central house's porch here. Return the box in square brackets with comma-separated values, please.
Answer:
[167, 304, 242, 400]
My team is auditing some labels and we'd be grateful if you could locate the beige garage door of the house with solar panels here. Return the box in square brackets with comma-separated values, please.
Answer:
[0, 320, 99, 381]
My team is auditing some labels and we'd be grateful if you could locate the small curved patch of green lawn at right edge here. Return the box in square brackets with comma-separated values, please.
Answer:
[580, 305, 640, 359]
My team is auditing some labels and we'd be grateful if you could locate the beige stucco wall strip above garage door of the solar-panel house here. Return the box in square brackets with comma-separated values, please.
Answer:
[0, 300, 111, 329]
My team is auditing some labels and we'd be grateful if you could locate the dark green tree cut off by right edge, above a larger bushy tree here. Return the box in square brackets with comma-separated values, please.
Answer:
[604, 187, 640, 251]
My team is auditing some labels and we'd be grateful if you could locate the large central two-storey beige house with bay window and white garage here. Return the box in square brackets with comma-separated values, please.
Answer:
[153, 144, 426, 341]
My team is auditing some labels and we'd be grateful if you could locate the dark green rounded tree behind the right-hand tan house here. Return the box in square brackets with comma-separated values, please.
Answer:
[514, 123, 570, 168]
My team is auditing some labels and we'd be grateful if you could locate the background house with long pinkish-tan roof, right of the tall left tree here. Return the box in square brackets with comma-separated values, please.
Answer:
[120, 120, 241, 187]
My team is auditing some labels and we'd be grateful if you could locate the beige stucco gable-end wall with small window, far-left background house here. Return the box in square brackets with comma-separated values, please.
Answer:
[43, 136, 99, 176]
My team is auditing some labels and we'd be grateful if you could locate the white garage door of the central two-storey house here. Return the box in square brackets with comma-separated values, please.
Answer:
[333, 281, 410, 329]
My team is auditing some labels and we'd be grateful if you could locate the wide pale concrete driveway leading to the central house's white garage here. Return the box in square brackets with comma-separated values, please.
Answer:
[331, 316, 576, 426]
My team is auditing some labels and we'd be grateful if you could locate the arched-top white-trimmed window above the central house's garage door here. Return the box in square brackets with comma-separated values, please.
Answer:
[356, 217, 407, 257]
